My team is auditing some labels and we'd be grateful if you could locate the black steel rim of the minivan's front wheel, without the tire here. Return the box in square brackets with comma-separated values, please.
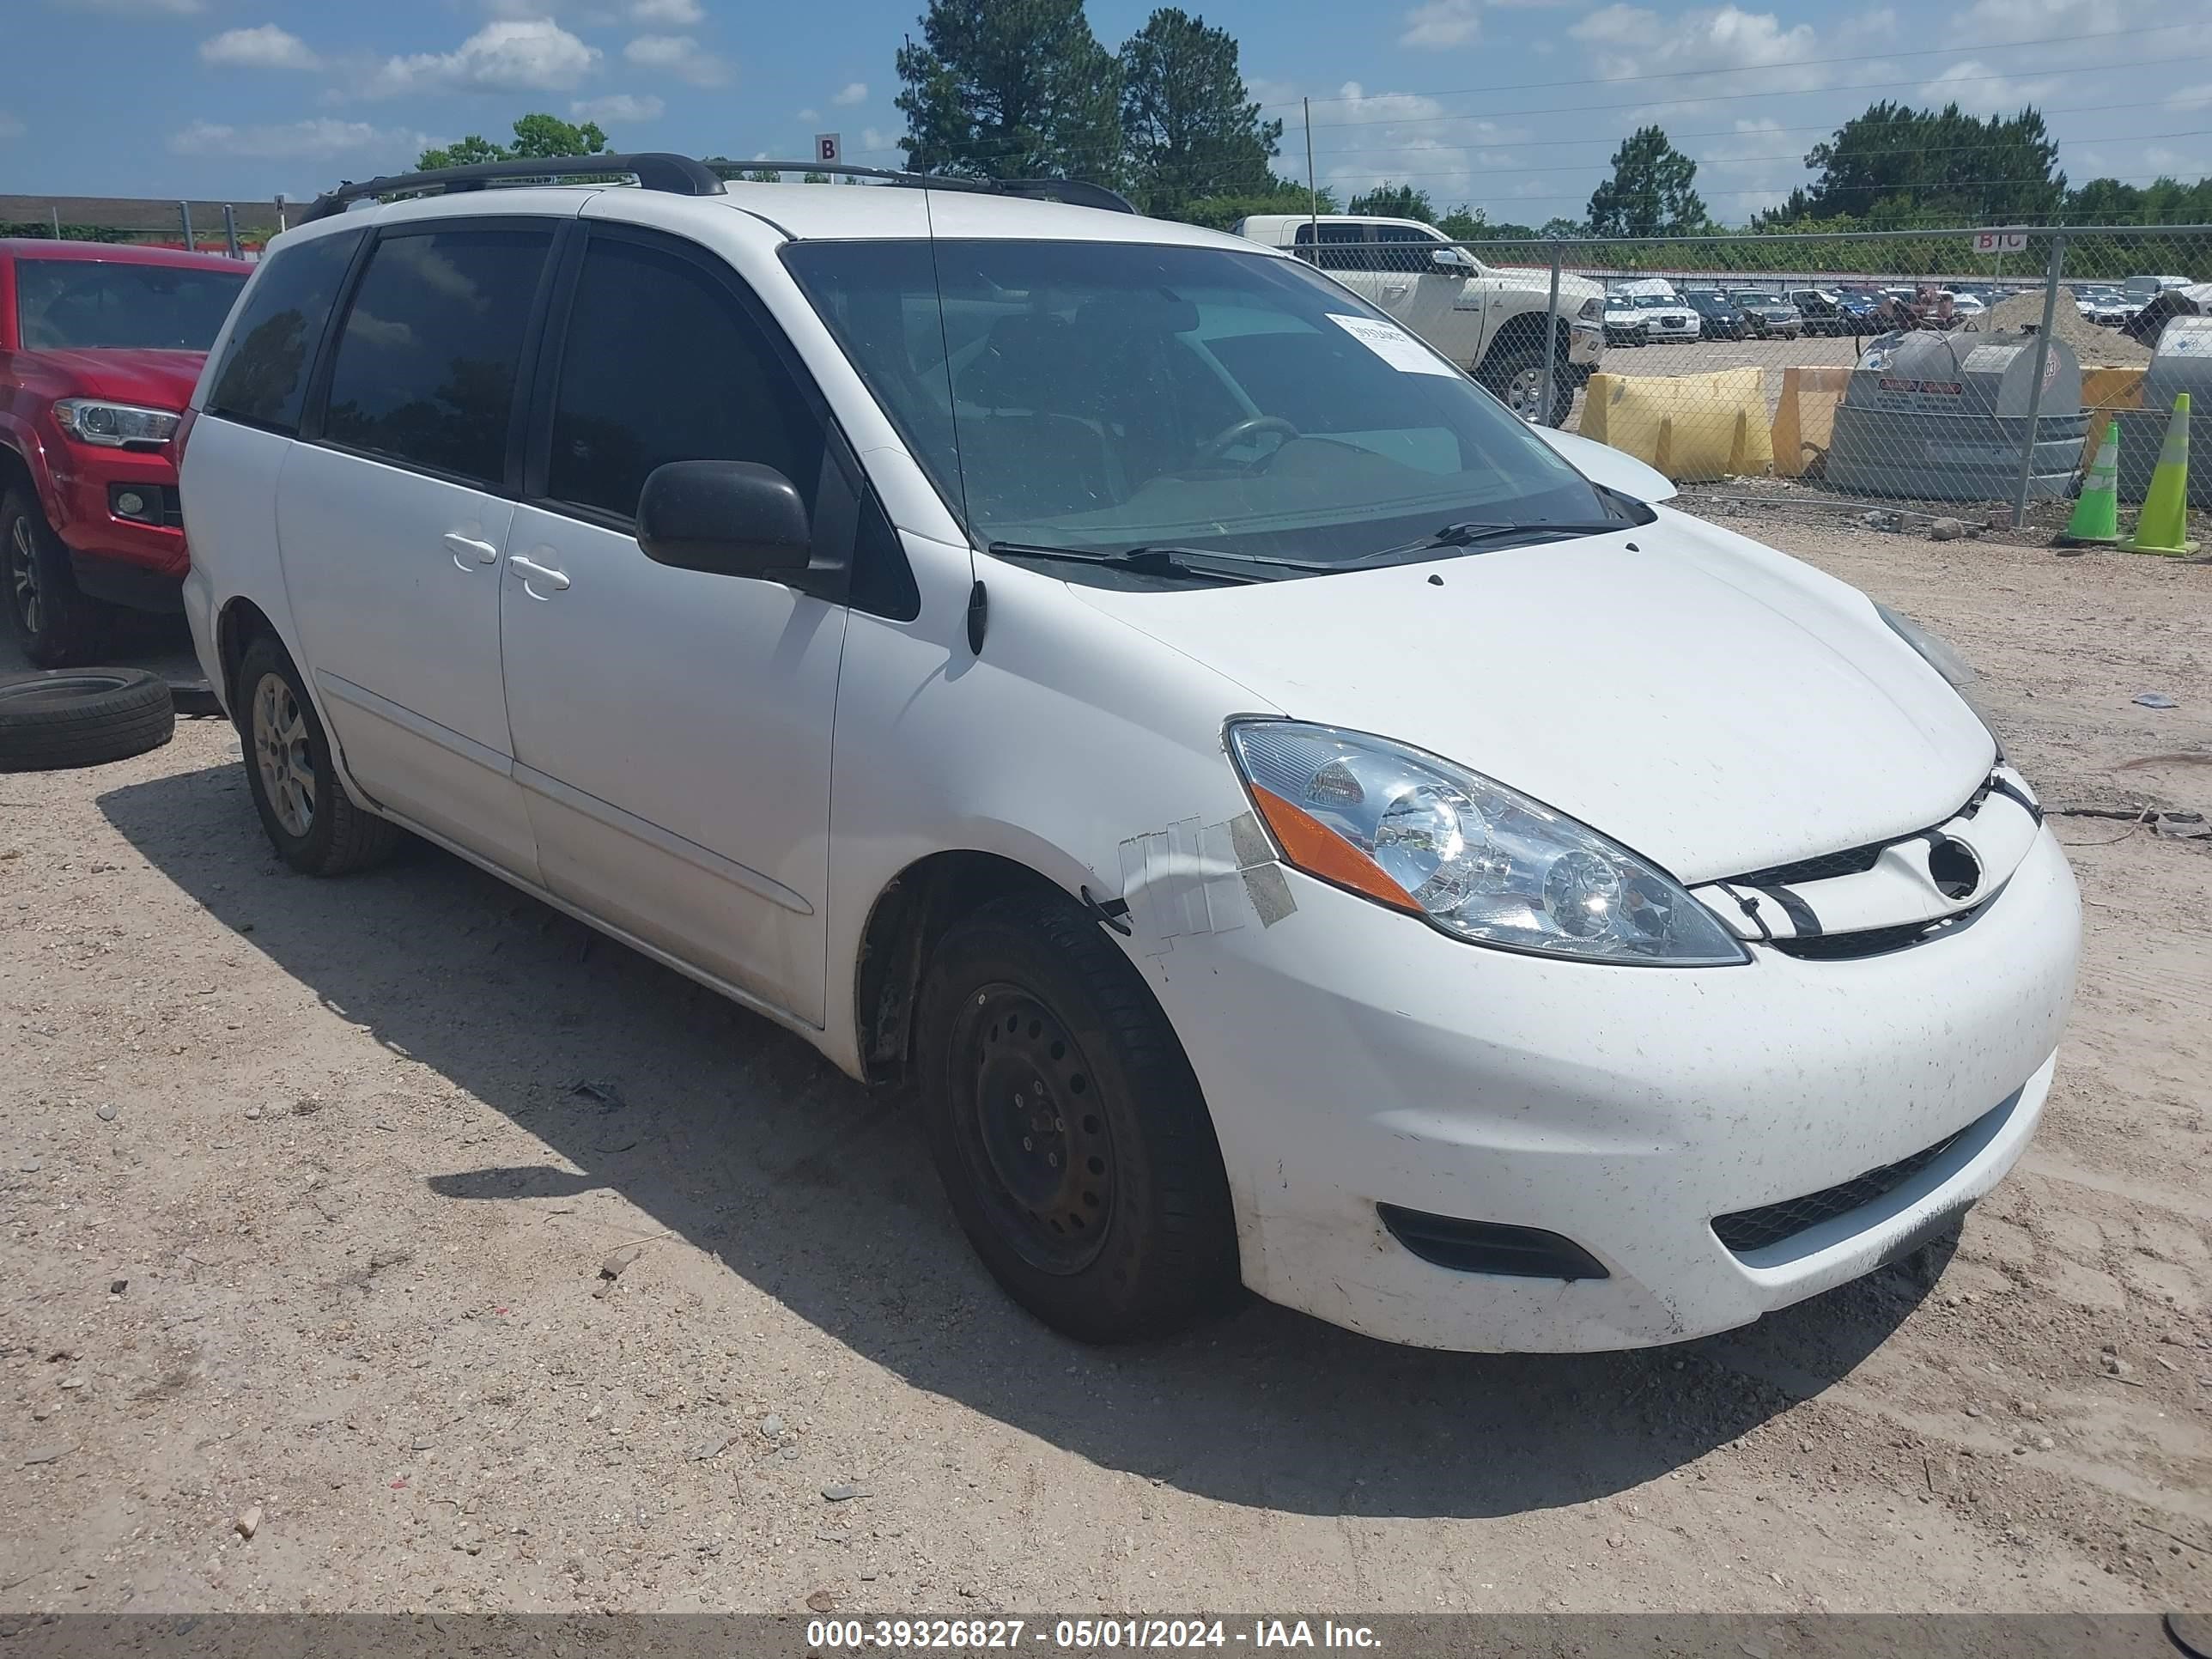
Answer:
[953, 984, 1117, 1276]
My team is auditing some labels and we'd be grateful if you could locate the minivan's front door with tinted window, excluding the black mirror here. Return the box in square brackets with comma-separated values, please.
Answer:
[500, 226, 845, 1024]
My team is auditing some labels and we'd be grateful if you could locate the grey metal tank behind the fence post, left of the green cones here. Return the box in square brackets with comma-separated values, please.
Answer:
[1827, 330, 2088, 502]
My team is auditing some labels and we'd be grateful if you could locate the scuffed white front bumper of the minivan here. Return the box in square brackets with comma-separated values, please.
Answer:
[1148, 830, 2081, 1352]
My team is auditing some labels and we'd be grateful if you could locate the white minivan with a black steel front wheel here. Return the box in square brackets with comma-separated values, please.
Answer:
[181, 157, 2079, 1349]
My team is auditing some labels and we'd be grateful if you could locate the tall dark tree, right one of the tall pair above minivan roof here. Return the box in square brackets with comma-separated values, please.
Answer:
[1121, 7, 1283, 215]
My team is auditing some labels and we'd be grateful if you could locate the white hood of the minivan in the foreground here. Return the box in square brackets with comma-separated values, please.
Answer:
[1075, 508, 1996, 883]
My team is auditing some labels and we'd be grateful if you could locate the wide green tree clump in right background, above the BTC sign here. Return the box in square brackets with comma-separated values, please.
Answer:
[1792, 101, 2066, 228]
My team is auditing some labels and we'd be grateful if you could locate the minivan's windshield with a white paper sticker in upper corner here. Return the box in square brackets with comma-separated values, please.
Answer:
[783, 241, 1626, 577]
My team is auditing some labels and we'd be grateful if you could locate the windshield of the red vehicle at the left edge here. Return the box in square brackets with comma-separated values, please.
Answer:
[15, 254, 252, 352]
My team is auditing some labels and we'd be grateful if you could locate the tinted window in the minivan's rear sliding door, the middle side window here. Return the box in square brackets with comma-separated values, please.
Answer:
[323, 226, 553, 487]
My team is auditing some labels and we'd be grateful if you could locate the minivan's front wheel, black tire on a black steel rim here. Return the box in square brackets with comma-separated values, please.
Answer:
[918, 896, 1239, 1343]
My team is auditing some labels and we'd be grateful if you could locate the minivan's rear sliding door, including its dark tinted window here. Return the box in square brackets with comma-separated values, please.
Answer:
[276, 219, 553, 876]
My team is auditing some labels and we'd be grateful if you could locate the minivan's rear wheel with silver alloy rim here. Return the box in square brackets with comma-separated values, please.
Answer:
[234, 633, 407, 876]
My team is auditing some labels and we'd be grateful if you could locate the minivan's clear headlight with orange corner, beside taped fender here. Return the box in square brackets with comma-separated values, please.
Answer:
[1228, 721, 1750, 967]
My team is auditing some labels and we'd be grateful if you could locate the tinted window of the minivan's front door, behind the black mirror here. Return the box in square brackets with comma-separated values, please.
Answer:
[546, 237, 823, 520]
